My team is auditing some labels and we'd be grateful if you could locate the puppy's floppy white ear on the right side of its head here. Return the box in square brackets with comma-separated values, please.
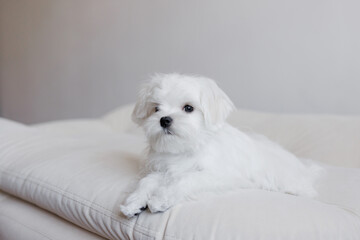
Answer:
[200, 79, 235, 128]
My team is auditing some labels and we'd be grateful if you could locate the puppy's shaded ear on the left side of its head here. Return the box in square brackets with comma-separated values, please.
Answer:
[131, 81, 153, 126]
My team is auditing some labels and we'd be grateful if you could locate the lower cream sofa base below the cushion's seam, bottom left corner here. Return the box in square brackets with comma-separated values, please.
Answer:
[0, 192, 104, 240]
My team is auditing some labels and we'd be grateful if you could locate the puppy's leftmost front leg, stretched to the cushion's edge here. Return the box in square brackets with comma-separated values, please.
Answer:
[120, 173, 162, 218]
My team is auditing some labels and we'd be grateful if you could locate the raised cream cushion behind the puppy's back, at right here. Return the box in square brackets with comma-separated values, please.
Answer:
[230, 111, 360, 167]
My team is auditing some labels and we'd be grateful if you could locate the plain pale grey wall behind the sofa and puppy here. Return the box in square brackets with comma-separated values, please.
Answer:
[0, 0, 360, 123]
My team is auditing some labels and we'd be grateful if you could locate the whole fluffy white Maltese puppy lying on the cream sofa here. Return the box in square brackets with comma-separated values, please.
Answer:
[120, 74, 321, 217]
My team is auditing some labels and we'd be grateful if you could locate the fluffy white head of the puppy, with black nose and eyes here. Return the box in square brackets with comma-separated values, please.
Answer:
[132, 74, 234, 153]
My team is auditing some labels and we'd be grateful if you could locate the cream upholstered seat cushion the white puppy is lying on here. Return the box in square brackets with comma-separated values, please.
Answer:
[0, 108, 360, 240]
